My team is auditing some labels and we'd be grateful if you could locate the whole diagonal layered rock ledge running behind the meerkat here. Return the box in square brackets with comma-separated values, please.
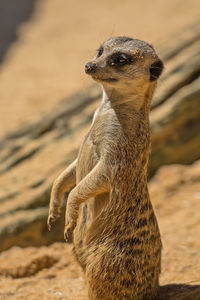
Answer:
[0, 25, 200, 250]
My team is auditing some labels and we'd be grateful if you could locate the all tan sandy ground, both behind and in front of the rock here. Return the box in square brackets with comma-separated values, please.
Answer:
[0, 0, 200, 300]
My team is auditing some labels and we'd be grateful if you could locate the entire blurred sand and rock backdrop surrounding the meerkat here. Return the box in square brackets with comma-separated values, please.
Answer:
[0, 0, 200, 300]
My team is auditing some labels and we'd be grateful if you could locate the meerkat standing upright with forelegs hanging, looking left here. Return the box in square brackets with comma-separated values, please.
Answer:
[48, 36, 163, 300]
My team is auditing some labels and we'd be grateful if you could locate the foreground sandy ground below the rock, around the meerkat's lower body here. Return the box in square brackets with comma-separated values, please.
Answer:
[0, 161, 200, 300]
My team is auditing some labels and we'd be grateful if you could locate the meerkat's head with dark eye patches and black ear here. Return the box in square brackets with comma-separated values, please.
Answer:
[85, 36, 163, 97]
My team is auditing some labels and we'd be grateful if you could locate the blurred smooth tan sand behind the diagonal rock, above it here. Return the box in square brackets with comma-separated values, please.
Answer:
[0, 0, 200, 136]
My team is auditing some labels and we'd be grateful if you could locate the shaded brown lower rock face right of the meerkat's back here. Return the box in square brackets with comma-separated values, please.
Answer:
[149, 77, 200, 177]
